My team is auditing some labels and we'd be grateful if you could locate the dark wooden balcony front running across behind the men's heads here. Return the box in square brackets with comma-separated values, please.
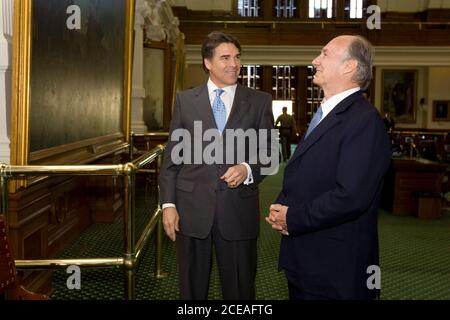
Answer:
[180, 20, 450, 46]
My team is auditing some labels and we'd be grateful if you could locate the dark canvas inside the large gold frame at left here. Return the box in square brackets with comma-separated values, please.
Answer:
[29, 0, 126, 152]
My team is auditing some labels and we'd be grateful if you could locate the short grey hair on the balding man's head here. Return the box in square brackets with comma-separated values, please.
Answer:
[348, 36, 373, 90]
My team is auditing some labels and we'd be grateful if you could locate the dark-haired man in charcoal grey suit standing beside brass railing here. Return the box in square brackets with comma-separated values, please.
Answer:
[160, 32, 278, 299]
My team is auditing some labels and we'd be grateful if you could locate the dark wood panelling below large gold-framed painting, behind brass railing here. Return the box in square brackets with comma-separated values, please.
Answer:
[9, 177, 90, 293]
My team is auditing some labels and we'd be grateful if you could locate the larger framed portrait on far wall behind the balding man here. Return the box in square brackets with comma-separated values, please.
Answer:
[381, 69, 417, 123]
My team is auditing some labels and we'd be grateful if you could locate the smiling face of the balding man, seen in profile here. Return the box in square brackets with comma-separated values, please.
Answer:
[312, 37, 350, 88]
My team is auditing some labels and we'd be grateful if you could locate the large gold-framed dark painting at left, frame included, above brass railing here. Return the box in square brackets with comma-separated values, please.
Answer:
[11, 0, 135, 165]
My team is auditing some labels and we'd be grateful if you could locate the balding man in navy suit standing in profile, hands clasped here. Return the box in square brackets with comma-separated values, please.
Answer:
[266, 36, 391, 299]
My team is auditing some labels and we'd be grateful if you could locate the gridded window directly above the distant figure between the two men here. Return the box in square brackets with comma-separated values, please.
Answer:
[272, 66, 296, 100]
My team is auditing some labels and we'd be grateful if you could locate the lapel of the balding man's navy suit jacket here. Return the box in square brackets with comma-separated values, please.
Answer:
[286, 91, 361, 166]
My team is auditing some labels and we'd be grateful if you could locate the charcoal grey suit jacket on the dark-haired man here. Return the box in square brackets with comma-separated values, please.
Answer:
[160, 85, 273, 240]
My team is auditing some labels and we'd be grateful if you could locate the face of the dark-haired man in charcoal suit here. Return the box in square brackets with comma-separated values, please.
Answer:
[204, 43, 241, 88]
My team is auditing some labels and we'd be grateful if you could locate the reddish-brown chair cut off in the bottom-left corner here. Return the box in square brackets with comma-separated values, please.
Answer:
[0, 215, 48, 300]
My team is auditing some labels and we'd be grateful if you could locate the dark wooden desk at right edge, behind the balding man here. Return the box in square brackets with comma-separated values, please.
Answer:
[381, 158, 448, 215]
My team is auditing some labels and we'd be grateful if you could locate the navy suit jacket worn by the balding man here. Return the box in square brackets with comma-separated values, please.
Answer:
[276, 92, 391, 299]
